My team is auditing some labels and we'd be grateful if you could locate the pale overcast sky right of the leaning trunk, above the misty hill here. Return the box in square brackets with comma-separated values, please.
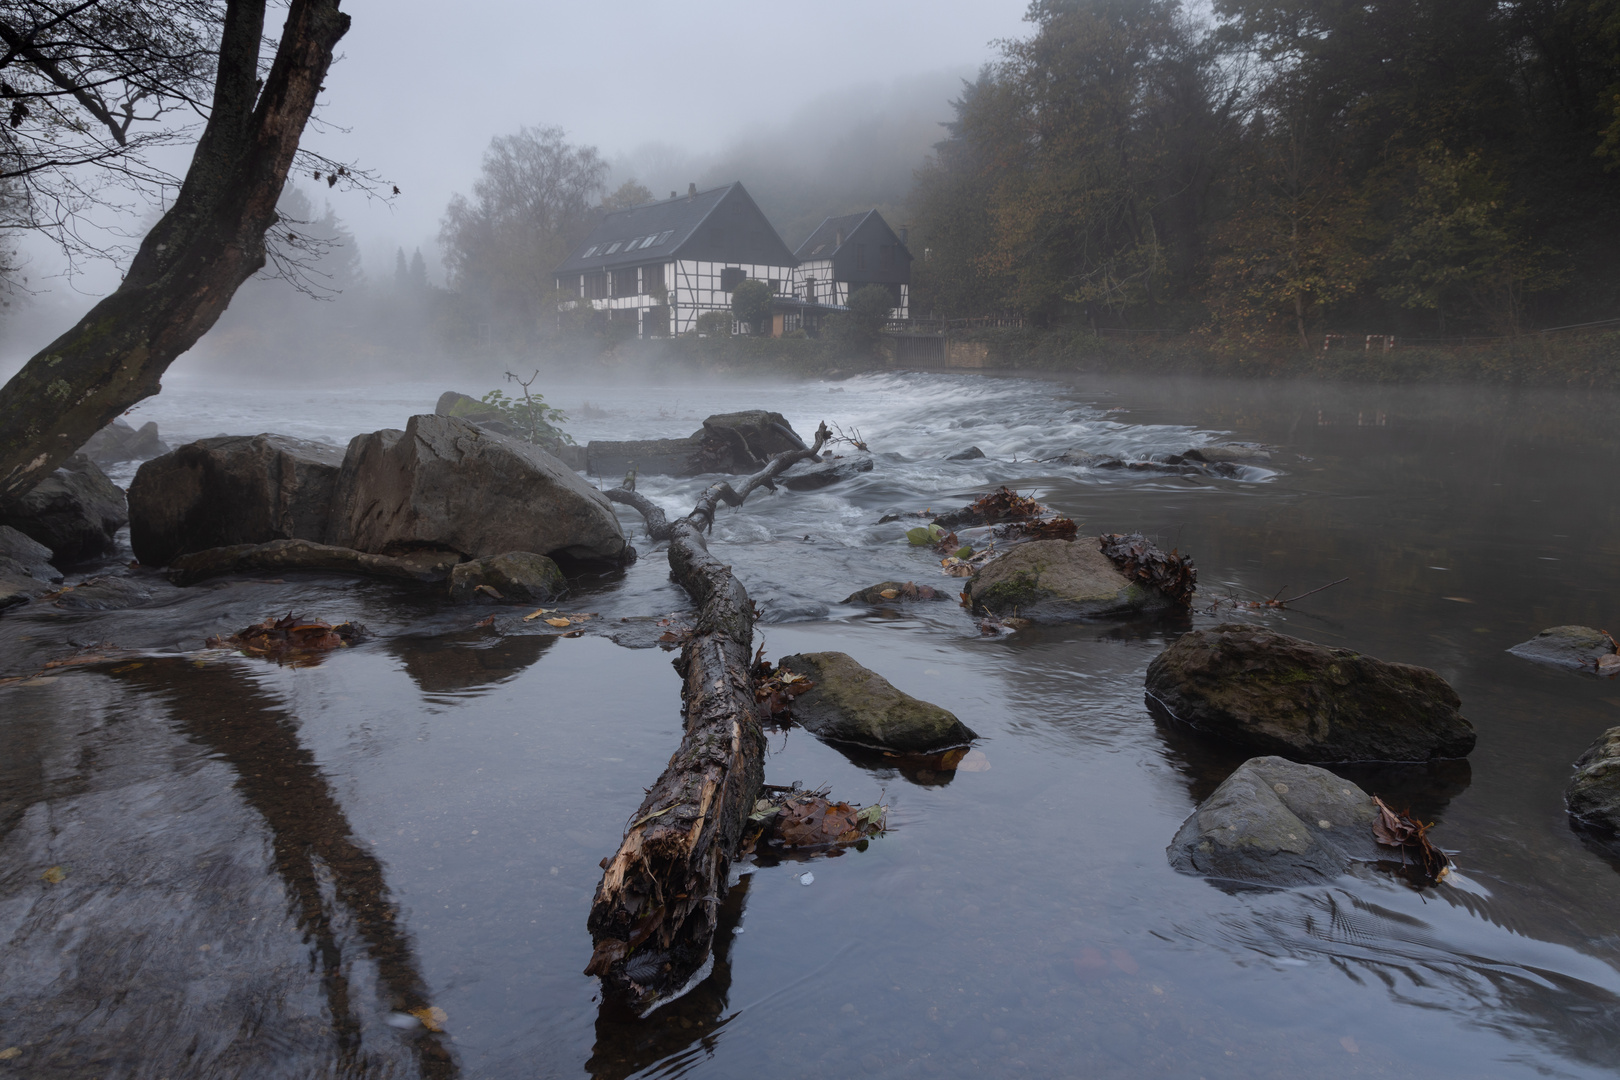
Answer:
[308, 0, 1027, 261]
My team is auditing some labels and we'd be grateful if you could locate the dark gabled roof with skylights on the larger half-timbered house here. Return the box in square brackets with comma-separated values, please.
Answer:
[554, 183, 792, 274]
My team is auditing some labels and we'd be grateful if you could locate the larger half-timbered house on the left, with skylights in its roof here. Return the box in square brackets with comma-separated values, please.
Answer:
[556, 183, 794, 337]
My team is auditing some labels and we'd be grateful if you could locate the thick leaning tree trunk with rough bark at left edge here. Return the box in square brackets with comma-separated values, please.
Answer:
[0, 0, 348, 507]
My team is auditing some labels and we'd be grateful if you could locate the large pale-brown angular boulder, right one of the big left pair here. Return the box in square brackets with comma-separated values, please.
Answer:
[329, 416, 629, 562]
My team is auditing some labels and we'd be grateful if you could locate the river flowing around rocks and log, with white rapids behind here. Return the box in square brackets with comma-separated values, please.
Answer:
[0, 372, 1620, 1080]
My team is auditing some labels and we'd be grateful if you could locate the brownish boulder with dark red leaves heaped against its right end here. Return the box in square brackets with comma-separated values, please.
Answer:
[966, 538, 1173, 623]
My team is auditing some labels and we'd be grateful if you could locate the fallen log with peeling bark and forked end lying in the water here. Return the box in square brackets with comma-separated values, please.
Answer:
[585, 424, 831, 1006]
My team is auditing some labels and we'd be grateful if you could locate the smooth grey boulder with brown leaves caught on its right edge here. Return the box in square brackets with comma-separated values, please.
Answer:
[1170, 758, 1393, 886]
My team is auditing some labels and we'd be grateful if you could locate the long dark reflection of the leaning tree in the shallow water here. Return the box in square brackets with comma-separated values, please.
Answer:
[113, 659, 457, 1078]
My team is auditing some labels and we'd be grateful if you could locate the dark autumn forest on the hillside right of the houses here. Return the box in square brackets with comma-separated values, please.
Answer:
[910, 0, 1620, 345]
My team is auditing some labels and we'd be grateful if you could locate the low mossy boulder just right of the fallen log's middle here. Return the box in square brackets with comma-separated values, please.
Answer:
[776, 653, 978, 755]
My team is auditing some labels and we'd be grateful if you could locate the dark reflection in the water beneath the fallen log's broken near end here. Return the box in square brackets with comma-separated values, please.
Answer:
[585, 874, 753, 1080]
